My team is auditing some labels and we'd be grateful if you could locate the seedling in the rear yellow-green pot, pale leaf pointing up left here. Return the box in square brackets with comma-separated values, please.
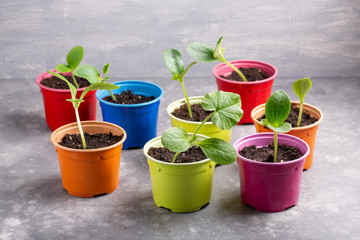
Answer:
[163, 49, 197, 118]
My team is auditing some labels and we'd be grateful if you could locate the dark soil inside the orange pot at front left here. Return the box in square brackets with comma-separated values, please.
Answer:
[59, 132, 124, 149]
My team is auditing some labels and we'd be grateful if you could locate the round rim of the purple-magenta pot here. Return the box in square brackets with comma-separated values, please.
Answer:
[233, 132, 310, 166]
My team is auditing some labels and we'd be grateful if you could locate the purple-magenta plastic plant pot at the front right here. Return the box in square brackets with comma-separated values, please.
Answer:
[234, 133, 310, 212]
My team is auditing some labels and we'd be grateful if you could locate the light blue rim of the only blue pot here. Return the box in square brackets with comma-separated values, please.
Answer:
[96, 80, 164, 108]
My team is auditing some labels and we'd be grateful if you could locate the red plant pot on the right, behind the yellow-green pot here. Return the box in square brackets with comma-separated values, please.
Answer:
[212, 60, 278, 124]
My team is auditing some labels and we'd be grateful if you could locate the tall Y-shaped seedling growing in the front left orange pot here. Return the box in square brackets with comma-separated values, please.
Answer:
[47, 71, 119, 149]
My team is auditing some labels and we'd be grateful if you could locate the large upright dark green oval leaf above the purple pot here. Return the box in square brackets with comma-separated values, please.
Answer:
[265, 90, 291, 128]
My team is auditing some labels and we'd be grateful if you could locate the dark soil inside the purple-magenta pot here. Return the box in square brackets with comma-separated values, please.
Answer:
[239, 143, 302, 162]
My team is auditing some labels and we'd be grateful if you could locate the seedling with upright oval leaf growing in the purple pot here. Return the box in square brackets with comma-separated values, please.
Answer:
[260, 90, 291, 162]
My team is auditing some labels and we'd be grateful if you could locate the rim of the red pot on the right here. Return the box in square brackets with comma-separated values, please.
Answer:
[212, 60, 278, 85]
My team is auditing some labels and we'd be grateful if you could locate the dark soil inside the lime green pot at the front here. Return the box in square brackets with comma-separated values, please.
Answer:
[148, 146, 207, 163]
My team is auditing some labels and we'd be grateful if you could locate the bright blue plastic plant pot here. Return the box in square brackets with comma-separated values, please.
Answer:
[96, 81, 163, 149]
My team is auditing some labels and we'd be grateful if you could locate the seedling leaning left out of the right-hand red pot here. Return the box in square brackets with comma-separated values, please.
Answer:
[186, 37, 247, 82]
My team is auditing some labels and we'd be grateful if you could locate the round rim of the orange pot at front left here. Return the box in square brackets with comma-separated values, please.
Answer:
[50, 121, 127, 153]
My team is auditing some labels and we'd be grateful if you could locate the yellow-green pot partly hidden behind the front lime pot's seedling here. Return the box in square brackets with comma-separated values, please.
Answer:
[167, 96, 231, 142]
